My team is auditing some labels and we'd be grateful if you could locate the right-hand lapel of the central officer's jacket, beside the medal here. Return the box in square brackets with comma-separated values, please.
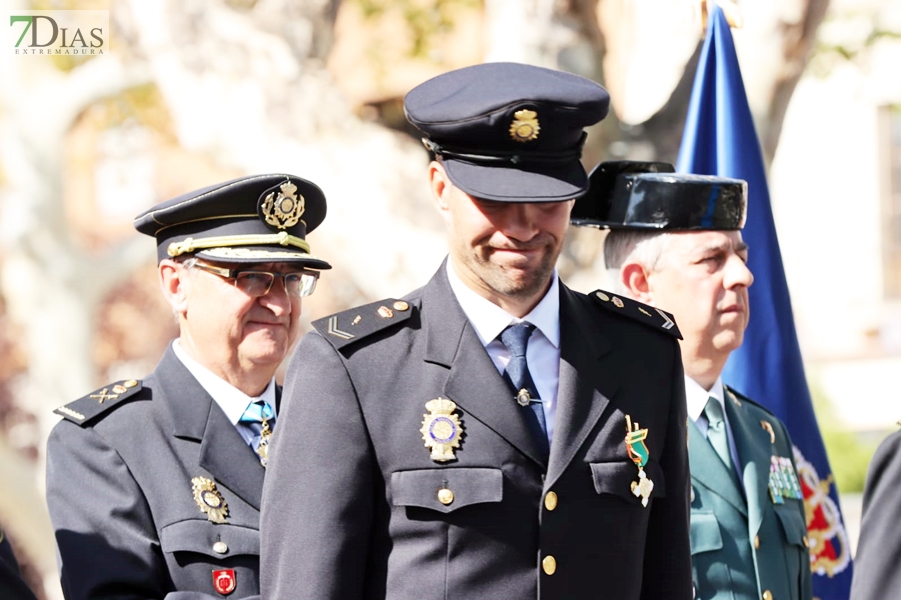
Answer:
[547, 282, 620, 486]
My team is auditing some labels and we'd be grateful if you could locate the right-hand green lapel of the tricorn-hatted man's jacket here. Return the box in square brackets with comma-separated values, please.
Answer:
[725, 389, 770, 535]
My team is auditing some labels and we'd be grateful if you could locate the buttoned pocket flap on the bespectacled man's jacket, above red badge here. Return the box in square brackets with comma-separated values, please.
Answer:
[160, 519, 260, 559]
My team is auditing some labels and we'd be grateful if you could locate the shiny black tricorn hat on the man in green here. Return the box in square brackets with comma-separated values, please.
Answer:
[570, 161, 748, 231]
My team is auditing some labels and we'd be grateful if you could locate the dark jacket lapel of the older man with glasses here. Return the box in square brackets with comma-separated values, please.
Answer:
[155, 347, 266, 509]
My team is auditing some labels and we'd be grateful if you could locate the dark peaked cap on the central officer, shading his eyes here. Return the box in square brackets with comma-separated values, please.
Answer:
[404, 63, 610, 202]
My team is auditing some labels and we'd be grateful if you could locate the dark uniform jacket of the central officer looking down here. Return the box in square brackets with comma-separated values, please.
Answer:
[261, 267, 691, 600]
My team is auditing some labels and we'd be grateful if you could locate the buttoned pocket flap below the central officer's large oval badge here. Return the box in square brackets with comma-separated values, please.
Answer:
[391, 467, 504, 513]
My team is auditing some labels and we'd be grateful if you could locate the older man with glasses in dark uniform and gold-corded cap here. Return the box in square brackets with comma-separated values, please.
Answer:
[47, 174, 330, 600]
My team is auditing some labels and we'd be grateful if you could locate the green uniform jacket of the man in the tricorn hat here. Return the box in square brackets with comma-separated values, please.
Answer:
[688, 389, 813, 600]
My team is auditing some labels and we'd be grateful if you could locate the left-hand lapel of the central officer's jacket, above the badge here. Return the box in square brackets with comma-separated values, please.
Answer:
[422, 264, 547, 467]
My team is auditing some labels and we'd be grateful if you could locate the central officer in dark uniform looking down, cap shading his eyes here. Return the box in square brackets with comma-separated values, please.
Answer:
[261, 63, 691, 600]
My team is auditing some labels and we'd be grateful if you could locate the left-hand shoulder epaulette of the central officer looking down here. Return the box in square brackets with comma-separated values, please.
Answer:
[313, 298, 413, 350]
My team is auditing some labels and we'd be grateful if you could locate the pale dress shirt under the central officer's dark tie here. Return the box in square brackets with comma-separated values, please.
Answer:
[447, 260, 560, 444]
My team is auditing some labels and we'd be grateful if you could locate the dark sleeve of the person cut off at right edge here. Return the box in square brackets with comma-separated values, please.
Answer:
[851, 431, 901, 600]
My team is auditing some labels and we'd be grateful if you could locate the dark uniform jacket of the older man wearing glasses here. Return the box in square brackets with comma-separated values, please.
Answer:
[47, 347, 265, 600]
